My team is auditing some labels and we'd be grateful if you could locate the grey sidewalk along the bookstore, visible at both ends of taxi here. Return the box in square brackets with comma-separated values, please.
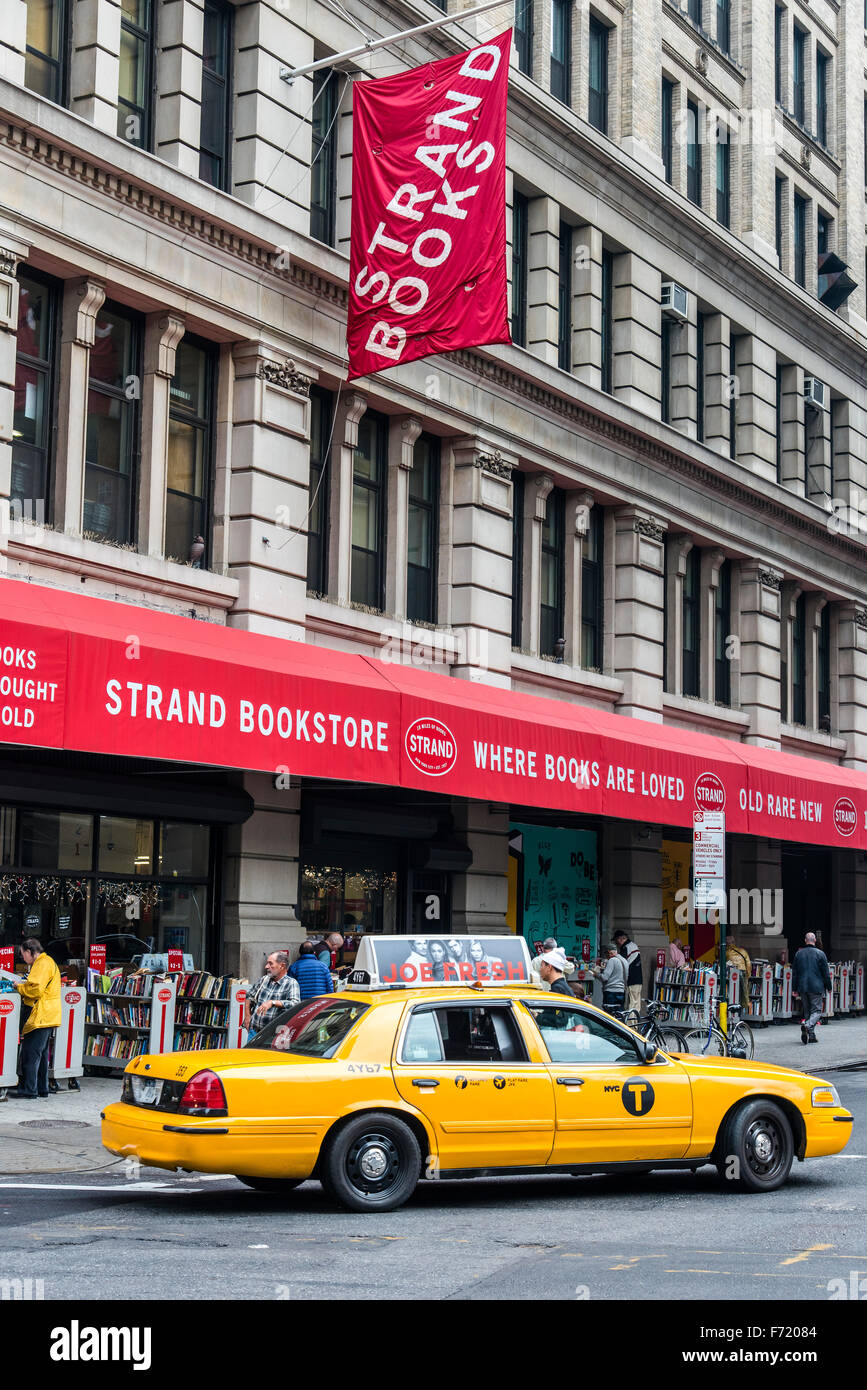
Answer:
[0, 1016, 867, 1182]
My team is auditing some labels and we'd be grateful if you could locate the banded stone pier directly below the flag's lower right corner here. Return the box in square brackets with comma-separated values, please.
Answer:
[452, 439, 517, 686]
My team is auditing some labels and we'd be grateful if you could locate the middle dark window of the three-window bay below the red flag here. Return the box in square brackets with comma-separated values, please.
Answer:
[350, 410, 388, 612]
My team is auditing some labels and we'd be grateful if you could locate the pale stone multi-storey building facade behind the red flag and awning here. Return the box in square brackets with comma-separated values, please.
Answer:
[0, 0, 867, 989]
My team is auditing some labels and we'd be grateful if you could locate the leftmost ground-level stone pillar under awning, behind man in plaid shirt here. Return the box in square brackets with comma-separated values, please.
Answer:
[224, 773, 304, 981]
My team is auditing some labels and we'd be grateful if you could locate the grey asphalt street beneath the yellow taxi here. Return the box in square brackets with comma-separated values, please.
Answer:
[0, 1070, 867, 1302]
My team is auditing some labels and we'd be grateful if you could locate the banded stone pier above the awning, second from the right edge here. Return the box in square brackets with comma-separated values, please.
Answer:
[741, 563, 782, 748]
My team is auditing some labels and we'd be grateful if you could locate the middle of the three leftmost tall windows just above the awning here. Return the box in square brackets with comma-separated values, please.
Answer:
[83, 302, 142, 545]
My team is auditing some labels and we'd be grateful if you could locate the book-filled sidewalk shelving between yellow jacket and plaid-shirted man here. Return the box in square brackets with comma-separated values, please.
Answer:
[83, 970, 247, 1070]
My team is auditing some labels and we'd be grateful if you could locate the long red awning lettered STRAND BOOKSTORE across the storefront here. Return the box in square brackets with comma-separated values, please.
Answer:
[0, 580, 867, 848]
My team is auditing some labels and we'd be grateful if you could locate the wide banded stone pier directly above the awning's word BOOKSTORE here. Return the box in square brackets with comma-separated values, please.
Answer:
[228, 343, 315, 638]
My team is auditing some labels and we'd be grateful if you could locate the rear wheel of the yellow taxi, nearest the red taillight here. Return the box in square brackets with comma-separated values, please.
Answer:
[320, 1111, 421, 1212]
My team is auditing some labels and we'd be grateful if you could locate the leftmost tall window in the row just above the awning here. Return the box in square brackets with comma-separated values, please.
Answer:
[10, 272, 60, 521]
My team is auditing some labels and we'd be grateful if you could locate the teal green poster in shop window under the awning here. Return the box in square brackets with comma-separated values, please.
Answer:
[509, 824, 599, 959]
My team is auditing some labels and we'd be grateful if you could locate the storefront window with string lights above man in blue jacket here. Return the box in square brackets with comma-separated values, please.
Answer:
[302, 865, 397, 935]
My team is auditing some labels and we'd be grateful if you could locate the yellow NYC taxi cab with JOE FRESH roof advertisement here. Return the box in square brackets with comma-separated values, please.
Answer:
[103, 938, 853, 1212]
